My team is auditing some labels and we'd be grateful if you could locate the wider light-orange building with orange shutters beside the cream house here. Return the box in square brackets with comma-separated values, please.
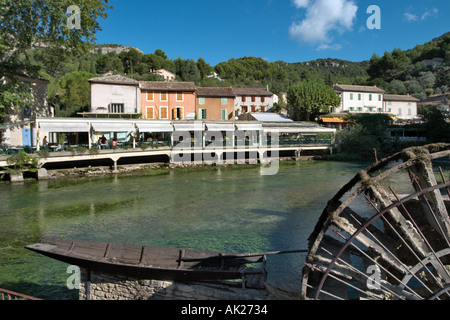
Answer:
[140, 81, 196, 120]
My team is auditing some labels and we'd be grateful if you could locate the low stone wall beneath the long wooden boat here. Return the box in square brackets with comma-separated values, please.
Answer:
[79, 270, 268, 300]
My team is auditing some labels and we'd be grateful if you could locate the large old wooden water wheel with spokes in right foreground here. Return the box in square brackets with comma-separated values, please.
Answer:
[301, 144, 450, 300]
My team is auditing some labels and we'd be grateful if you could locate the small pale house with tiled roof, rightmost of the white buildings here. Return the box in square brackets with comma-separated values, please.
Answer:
[384, 94, 419, 120]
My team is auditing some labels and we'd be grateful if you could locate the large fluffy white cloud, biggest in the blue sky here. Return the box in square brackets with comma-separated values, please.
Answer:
[289, 0, 358, 50]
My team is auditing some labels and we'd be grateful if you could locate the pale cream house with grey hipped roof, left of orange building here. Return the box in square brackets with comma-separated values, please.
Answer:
[85, 75, 141, 117]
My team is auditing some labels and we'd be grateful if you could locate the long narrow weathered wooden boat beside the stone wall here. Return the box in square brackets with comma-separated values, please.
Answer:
[25, 240, 266, 281]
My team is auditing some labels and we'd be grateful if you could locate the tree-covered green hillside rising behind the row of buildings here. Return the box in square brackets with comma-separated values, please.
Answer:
[23, 33, 450, 116]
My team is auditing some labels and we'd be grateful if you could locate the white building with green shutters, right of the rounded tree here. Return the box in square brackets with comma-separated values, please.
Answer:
[330, 84, 384, 113]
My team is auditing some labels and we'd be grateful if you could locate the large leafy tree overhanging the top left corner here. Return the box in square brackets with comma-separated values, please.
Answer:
[0, 0, 111, 122]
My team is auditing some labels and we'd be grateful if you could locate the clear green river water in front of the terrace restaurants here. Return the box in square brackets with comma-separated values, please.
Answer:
[0, 162, 365, 300]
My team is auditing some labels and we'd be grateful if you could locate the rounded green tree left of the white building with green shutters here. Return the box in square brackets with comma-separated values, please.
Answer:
[287, 80, 341, 121]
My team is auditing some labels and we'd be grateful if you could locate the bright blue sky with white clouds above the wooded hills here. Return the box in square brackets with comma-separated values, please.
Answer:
[93, 0, 450, 66]
